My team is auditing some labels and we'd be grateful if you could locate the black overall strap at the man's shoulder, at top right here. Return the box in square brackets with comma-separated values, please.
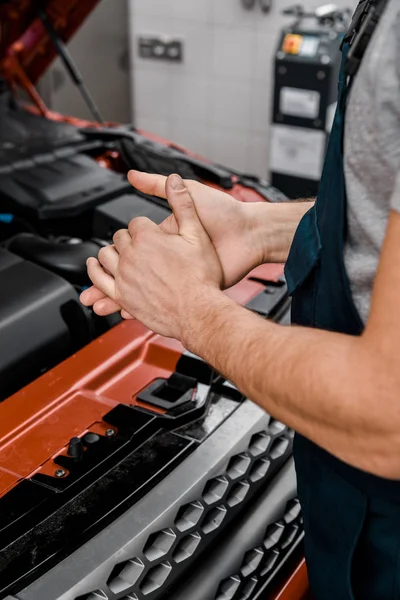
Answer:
[343, 0, 388, 79]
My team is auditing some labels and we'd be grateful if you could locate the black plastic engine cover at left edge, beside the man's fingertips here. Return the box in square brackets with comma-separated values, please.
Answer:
[0, 249, 88, 400]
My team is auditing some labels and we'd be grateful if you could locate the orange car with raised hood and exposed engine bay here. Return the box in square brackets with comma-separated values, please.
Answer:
[0, 0, 307, 600]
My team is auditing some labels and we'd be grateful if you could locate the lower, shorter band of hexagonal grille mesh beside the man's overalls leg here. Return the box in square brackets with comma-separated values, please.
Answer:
[211, 499, 302, 600]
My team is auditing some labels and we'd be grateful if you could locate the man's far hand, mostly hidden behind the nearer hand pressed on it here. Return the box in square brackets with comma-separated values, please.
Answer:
[81, 171, 312, 319]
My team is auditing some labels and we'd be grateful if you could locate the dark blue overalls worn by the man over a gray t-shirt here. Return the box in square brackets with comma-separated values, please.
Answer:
[286, 2, 400, 600]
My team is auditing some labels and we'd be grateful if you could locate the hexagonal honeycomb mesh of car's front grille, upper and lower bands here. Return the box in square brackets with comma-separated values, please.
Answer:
[75, 428, 294, 600]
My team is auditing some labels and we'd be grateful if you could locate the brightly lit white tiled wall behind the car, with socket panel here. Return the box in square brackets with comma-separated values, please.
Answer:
[129, 0, 356, 177]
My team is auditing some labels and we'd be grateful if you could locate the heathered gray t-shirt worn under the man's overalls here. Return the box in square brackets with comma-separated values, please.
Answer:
[345, 0, 400, 322]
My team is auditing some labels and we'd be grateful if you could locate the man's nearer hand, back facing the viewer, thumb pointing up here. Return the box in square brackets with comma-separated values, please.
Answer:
[83, 175, 224, 340]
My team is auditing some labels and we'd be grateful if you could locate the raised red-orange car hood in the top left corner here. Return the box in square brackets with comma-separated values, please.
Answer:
[0, 0, 100, 83]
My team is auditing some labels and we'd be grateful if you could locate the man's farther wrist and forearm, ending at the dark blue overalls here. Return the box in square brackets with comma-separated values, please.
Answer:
[246, 200, 314, 264]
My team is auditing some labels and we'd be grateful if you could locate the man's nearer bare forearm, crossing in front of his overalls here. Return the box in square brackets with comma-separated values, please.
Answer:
[184, 293, 400, 477]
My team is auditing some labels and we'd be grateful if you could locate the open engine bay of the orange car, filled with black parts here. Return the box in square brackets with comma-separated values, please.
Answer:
[0, 80, 284, 401]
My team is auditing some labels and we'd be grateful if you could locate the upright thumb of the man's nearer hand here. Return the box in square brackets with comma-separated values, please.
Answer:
[165, 175, 205, 237]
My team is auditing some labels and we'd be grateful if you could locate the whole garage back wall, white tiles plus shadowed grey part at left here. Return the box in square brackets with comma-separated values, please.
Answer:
[41, 0, 355, 177]
